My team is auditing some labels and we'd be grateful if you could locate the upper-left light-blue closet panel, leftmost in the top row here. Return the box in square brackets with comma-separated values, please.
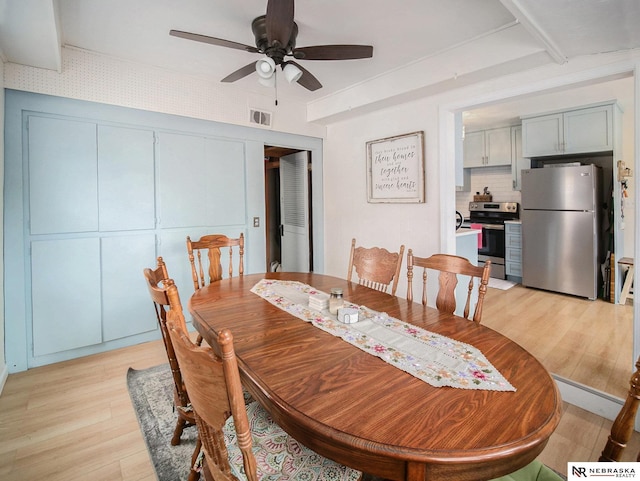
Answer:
[28, 116, 98, 235]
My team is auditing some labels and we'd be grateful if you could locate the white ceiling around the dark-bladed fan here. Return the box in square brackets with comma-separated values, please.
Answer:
[0, 0, 640, 109]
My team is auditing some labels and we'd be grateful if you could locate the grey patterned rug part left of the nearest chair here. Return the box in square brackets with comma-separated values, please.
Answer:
[127, 364, 196, 481]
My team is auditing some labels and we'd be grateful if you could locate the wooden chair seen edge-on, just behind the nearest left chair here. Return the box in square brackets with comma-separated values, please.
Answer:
[143, 257, 200, 481]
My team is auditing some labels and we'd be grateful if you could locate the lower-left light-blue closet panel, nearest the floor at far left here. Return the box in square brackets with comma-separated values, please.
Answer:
[31, 238, 102, 357]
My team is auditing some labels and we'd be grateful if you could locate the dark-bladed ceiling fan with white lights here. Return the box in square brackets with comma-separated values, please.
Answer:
[169, 0, 373, 91]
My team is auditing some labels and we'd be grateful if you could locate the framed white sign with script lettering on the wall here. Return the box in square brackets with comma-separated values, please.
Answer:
[367, 131, 424, 203]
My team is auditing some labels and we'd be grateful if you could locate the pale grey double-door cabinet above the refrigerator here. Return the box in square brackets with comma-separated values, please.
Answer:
[522, 102, 619, 158]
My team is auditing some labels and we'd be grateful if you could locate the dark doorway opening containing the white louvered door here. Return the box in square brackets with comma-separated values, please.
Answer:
[264, 145, 313, 272]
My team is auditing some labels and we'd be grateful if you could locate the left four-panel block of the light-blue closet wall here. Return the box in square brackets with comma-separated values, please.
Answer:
[25, 116, 157, 358]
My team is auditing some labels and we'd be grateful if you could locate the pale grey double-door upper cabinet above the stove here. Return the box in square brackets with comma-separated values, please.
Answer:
[463, 127, 511, 168]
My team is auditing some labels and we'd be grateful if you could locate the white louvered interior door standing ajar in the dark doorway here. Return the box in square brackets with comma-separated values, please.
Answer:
[280, 152, 309, 272]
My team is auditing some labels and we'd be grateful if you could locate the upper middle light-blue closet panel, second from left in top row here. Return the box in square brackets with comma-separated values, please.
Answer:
[98, 125, 155, 231]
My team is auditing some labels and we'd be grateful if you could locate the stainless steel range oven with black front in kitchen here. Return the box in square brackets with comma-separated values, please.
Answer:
[469, 202, 520, 279]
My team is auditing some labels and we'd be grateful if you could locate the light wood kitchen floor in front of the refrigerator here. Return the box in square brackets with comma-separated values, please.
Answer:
[482, 285, 635, 399]
